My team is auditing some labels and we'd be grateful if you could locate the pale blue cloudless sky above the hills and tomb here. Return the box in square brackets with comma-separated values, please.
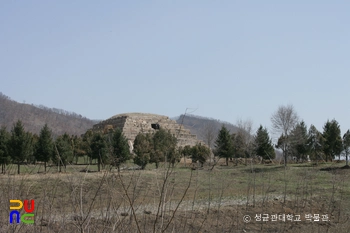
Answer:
[0, 0, 350, 137]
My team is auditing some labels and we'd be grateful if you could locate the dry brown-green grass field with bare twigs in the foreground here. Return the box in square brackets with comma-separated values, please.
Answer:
[0, 162, 350, 233]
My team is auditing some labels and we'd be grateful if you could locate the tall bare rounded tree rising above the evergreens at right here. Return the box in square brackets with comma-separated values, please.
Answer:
[271, 105, 299, 166]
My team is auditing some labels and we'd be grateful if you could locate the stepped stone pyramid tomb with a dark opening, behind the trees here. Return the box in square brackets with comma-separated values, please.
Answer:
[92, 113, 205, 147]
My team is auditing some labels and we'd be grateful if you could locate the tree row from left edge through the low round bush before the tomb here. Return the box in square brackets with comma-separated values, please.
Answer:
[0, 121, 210, 174]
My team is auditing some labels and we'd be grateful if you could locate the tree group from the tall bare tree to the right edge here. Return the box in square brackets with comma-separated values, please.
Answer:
[271, 105, 350, 165]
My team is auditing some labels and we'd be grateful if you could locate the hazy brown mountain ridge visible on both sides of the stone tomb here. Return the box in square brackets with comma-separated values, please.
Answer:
[0, 92, 238, 140]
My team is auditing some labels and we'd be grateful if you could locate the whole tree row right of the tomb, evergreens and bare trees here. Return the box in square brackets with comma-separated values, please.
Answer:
[214, 105, 350, 165]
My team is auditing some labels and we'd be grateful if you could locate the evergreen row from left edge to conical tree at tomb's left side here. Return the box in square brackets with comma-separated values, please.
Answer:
[0, 121, 130, 174]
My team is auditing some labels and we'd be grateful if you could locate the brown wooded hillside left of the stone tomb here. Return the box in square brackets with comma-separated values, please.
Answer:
[0, 92, 96, 135]
